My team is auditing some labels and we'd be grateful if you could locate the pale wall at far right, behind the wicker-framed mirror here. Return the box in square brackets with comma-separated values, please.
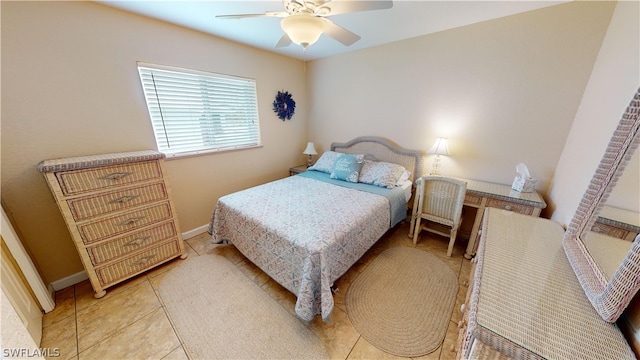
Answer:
[550, 1, 640, 224]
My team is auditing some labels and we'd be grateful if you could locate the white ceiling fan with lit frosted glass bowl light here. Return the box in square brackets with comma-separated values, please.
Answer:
[216, 0, 393, 50]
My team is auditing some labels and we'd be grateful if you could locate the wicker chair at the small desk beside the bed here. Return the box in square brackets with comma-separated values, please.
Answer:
[409, 175, 467, 256]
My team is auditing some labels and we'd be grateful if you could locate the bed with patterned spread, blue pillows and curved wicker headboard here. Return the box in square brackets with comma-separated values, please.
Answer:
[209, 137, 424, 321]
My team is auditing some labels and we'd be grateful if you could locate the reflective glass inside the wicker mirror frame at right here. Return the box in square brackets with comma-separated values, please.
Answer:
[581, 150, 640, 280]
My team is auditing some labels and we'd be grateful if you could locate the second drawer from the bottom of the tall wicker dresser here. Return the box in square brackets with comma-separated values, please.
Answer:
[87, 221, 178, 266]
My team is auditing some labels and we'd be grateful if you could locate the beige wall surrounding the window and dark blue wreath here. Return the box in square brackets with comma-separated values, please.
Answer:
[1, 1, 307, 282]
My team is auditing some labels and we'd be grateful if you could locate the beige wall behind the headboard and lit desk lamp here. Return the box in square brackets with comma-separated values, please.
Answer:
[308, 2, 615, 197]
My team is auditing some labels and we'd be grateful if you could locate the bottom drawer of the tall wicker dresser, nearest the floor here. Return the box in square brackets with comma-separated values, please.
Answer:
[96, 240, 181, 287]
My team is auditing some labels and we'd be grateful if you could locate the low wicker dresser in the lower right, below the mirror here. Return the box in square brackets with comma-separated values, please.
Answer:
[458, 209, 635, 359]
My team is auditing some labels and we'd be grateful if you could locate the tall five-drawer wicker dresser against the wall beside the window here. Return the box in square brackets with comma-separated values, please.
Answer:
[37, 150, 186, 298]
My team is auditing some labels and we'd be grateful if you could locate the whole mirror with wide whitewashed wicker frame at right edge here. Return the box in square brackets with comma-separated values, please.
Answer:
[563, 90, 640, 322]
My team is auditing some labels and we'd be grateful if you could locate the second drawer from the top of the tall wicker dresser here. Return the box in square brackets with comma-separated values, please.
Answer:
[67, 183, 168, 221]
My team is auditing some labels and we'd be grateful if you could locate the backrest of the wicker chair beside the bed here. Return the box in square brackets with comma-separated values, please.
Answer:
[418, 175, 467, 225]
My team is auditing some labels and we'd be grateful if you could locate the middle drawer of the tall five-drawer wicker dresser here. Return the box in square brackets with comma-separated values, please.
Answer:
[78, 202, 173, 244]
